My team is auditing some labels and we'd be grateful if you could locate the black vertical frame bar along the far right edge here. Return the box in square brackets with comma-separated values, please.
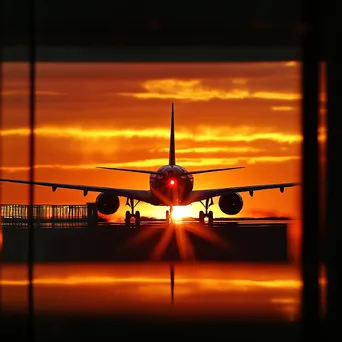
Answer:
[324, 0, 342, 341]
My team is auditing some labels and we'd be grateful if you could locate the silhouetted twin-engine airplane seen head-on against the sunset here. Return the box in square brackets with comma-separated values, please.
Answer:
[0, 104, 300, 227]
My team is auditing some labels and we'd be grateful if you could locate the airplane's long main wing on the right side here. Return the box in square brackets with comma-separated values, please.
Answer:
[187, 182, 300, 204]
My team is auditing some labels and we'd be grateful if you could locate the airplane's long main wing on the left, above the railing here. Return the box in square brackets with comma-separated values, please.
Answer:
[0, 178, 151, 203]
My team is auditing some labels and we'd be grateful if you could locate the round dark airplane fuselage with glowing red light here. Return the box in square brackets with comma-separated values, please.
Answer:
[150, 165, 194, 206]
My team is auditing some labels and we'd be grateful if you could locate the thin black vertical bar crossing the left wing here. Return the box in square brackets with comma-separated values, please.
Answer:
[27, 0, 36, 341]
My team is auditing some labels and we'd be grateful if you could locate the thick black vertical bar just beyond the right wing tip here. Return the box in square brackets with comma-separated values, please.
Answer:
[301, 0, 320, 338]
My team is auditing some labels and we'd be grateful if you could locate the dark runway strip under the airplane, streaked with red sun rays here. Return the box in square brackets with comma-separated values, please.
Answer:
[3, 220, 292, 263]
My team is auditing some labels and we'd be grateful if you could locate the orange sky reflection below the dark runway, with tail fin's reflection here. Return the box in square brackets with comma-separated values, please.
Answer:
[1, 263, 324, 321]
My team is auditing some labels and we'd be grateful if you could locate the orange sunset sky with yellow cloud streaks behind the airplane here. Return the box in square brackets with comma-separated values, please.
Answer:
[1, 62, 308, 217]
